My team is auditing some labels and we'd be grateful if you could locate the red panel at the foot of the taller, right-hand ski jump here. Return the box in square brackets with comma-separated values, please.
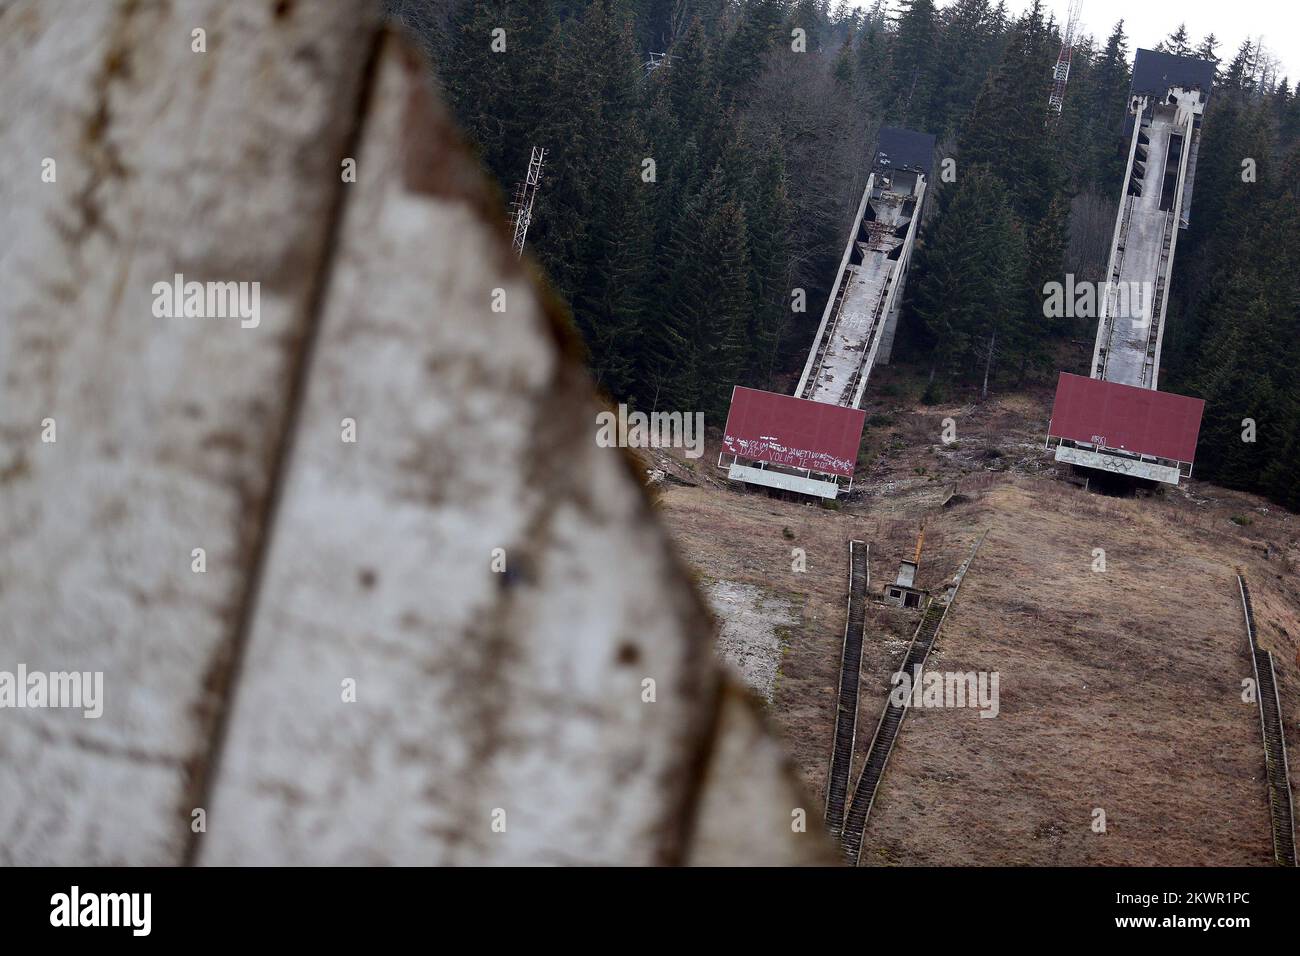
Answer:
[1048, 372, 1205, 462]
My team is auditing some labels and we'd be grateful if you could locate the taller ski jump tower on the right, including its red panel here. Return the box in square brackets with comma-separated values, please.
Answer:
[1048, 49, 1214, 484]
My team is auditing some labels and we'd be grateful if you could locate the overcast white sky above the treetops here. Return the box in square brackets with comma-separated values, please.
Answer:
[850, 0, 1300, 87]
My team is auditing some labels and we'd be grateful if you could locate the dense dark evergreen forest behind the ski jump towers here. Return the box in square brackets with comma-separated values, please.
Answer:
[387, 0, 1300, 509]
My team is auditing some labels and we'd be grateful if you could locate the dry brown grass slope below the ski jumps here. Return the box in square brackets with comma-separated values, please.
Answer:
[660, 382, 1300, 865]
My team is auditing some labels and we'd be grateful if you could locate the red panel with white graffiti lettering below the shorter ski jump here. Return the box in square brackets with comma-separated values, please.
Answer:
[723, 385, 867, 477]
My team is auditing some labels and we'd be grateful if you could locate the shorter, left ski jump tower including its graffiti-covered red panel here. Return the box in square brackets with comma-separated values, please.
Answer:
[718, 127, 935, 498]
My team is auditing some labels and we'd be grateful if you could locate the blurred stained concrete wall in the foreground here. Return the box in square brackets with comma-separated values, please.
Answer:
[0, 0, 835, 864]
